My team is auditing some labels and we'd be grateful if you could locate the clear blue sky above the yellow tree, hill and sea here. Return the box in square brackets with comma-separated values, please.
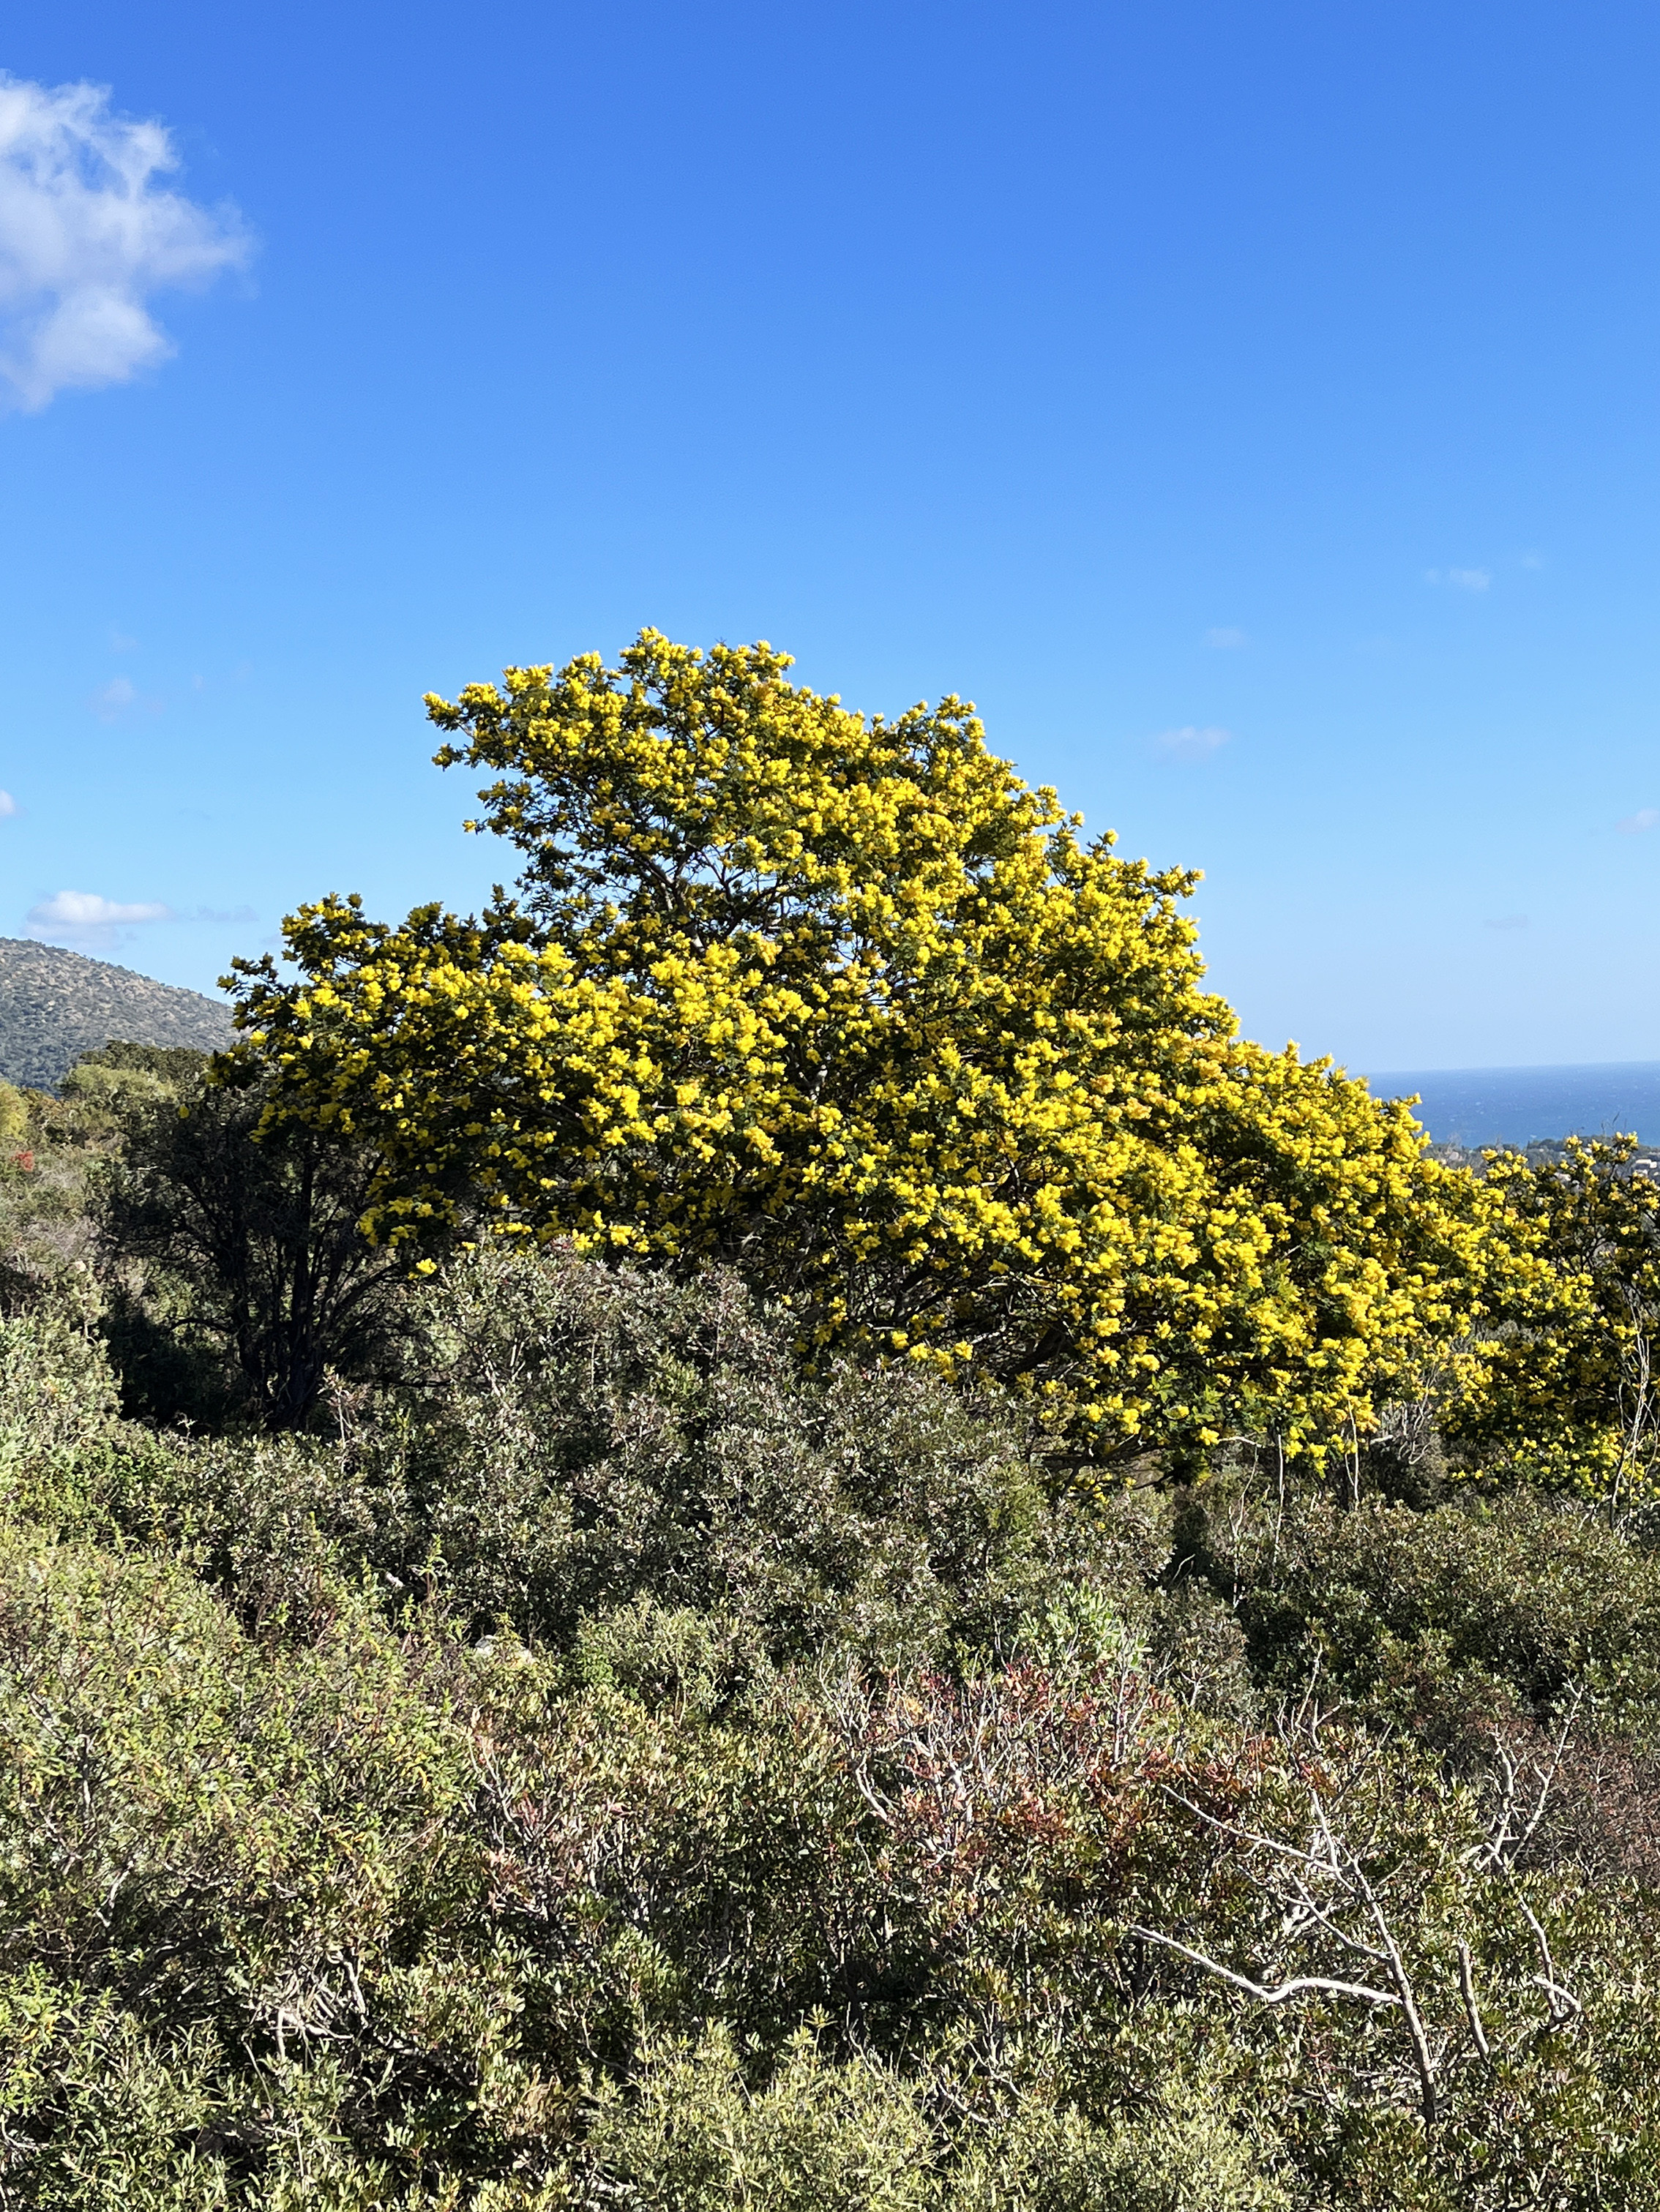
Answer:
[0, 0, 1660, 1068]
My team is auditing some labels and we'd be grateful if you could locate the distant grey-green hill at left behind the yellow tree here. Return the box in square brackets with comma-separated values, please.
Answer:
[0, 938, 230, 1090]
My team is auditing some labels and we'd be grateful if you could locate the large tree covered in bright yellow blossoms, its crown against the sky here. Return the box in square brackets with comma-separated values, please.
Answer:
[224, 631, 1459, 1455]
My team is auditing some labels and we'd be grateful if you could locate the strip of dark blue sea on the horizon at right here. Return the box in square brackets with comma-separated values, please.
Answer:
[1366, 1060, 1660, 1146]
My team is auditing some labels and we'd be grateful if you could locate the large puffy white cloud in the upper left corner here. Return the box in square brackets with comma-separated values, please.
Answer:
[0, 75, 248, 409]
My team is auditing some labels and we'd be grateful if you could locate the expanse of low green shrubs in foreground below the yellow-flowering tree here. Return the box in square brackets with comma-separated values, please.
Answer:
[0, 1248, 1660, 2212]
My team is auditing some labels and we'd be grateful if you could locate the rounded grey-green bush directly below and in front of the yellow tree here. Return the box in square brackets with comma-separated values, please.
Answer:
[378, 1248, 1126, 1665]
